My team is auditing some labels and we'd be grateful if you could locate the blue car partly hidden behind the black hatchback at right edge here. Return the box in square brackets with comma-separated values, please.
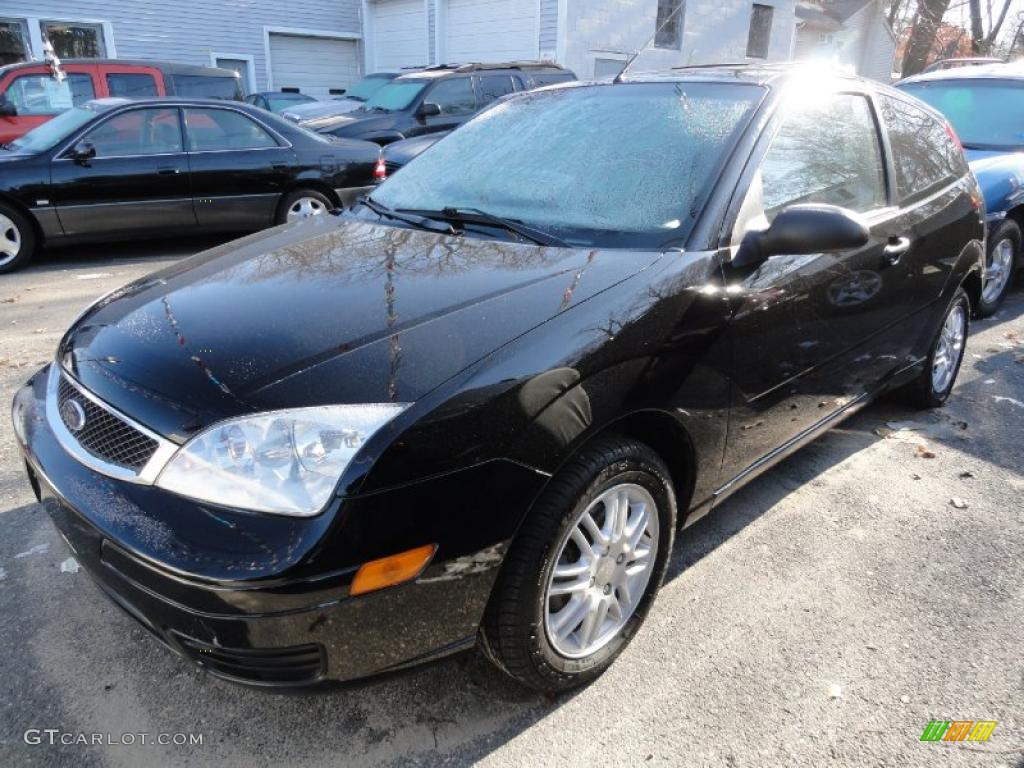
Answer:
[897, 65, 1024, 316]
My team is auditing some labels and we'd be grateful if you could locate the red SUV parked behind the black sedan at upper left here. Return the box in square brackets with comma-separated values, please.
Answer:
[0, 58, 242, 143]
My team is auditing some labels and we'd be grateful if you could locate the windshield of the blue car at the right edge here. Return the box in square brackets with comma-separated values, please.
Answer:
[900, 80, 1024, 150]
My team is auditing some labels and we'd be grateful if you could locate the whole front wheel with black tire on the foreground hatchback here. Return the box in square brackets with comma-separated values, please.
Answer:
[480, 437, 676, 693]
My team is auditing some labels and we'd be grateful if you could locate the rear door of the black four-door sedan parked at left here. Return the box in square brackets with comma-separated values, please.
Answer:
[183, 106, 296, 230]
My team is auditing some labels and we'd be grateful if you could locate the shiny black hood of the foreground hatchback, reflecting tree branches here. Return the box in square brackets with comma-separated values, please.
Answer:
[58, 216, 658, 441]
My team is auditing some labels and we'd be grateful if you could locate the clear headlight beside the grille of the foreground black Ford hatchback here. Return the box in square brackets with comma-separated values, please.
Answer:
[157, 403, 408, 517]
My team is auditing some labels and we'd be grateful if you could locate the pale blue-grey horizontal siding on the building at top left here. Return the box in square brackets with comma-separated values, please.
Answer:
[0, 0, 360, 89]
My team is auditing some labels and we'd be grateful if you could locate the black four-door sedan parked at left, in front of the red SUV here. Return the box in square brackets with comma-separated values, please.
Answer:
[0, 98, 380, 272]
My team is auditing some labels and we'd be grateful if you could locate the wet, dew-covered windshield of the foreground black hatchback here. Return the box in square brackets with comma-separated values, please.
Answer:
[373, 83, 764, 248]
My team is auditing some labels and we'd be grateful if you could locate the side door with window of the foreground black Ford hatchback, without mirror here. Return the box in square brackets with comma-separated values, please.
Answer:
[725, 93, 909, 477]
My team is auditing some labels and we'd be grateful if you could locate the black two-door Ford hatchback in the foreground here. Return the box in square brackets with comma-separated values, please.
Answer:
[13, 68, 983, 690]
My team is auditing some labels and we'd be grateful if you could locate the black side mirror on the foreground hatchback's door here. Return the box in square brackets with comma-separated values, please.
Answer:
[731, 204, 870, 268]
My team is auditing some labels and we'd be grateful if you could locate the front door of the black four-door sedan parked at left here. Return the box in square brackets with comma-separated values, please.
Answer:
[50, 106, 196, 236]
